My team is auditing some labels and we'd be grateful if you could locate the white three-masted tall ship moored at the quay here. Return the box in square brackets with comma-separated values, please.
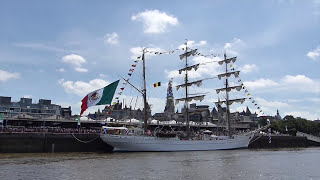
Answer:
[100, 43, 255, 151]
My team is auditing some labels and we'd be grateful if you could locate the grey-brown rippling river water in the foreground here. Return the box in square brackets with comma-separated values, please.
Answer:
[0, 148, 320, 180]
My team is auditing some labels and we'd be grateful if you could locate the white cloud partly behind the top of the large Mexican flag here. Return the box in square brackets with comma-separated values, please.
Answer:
[58, 79, 110, 97]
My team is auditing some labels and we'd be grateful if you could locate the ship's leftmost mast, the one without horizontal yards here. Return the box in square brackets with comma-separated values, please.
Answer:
[142, 48, 148, 133]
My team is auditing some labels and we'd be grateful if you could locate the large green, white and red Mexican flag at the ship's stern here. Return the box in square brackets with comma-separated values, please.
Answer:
[80, 80, 120, 116]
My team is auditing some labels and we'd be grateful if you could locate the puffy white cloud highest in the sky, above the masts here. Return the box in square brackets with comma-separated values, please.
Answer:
[131, 10, 179, 33]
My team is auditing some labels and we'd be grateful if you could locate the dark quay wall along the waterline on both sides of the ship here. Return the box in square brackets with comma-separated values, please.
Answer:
[0, 133, 320, 153]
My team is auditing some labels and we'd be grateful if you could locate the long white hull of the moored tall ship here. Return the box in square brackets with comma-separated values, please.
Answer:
[100, 133, 254, 151]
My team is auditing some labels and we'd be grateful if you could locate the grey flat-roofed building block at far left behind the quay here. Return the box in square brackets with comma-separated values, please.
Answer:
[0, 96, 71, 119]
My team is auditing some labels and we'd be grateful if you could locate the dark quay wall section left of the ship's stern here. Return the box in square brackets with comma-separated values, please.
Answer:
[0, 133, 113, 153]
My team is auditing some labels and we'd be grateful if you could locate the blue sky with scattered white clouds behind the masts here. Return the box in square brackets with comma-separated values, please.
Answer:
[0, 0, 320, 120]
